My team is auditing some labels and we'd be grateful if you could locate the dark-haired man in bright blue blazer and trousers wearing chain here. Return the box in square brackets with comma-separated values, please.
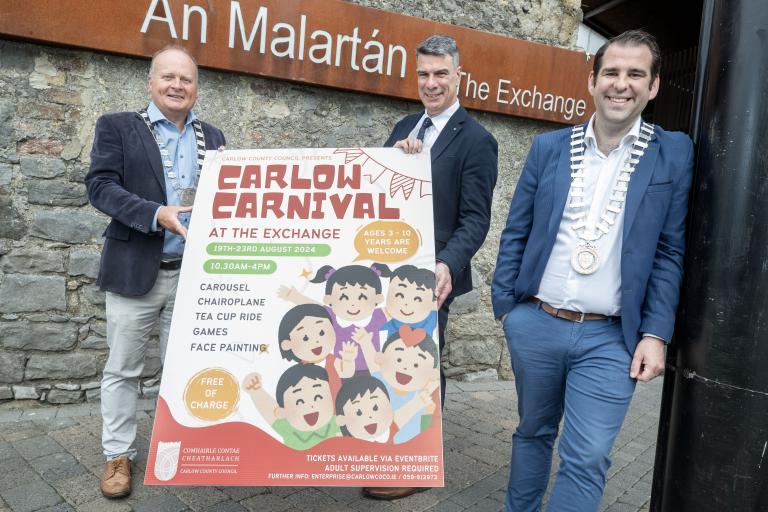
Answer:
[492, 31, 693, 512]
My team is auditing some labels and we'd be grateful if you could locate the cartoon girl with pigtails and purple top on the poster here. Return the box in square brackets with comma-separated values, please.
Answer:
[278, 263, 389, 372]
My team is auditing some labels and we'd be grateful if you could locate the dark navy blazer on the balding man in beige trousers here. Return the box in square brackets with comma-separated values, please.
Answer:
[85, 112, 225, 296]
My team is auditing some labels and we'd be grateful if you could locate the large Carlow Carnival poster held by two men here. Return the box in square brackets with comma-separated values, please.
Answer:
[145, 148, 443, 487]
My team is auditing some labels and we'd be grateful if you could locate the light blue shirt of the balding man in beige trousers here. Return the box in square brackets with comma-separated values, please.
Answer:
[147, 102, 197, 258]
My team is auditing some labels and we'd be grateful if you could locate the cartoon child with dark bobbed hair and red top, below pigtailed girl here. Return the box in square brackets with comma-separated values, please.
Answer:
[277, 304, 358, 399]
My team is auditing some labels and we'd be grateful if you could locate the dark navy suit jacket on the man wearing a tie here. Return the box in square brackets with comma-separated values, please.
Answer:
[384, 107, 499, 297]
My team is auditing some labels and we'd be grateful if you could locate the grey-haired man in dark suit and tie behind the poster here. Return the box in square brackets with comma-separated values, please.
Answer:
[365, 35, 498, 499]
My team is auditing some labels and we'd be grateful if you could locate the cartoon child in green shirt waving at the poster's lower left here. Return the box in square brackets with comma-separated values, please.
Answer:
[242, 364, 341, 450]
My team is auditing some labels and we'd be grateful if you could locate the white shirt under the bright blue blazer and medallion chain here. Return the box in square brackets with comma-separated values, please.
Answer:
[536, 116, 641, 316]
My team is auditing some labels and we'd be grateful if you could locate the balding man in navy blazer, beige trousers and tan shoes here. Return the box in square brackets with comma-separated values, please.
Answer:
[85, 47, 224, 498]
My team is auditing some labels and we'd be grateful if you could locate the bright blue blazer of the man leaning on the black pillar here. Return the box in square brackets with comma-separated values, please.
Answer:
[491, 126, 693, 353]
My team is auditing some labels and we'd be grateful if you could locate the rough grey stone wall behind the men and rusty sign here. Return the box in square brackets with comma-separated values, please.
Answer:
[0, 0, 581, 403]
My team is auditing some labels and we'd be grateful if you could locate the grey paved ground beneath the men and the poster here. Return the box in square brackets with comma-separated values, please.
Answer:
[0, 379, 661, 512]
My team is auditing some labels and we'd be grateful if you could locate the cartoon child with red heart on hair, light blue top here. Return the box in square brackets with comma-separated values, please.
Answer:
[352, 326, 440, 444]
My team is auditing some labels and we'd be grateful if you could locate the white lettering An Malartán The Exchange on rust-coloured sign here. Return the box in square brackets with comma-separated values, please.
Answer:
[126, 0, 588, 122]
